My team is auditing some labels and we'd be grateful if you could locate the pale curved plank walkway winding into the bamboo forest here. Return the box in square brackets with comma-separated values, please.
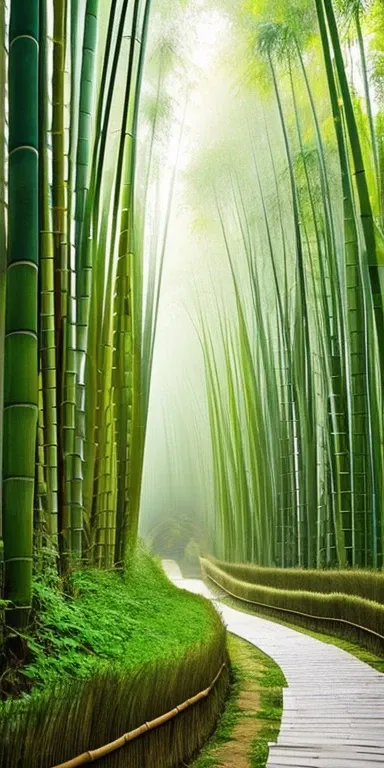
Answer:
[163, 560, 384, 768]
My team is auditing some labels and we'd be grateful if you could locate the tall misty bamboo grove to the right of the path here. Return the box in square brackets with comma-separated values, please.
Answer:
[191, 0, 384, 568]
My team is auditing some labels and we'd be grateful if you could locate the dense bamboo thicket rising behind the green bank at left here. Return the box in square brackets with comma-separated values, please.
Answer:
[0, 0, 177, 622]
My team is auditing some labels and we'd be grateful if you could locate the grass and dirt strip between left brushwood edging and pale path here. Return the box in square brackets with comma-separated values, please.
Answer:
[191, 635, 286, 768]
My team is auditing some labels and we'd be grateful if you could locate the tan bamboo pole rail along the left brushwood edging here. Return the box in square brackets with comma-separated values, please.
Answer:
[53, 663, 225, 768]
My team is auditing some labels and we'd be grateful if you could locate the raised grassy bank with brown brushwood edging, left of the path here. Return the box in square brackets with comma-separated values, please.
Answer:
[0, 551, 229, 768]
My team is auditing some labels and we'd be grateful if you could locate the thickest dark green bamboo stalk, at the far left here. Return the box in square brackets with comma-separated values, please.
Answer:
[3, 0, 39, 625]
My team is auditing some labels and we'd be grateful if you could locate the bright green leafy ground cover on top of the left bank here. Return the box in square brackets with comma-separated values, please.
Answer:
[0, 550, 220, 697]
